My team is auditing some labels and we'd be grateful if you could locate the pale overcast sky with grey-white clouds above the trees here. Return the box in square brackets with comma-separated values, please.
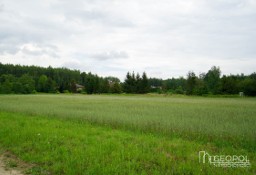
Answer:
[0, 0, 256, 79]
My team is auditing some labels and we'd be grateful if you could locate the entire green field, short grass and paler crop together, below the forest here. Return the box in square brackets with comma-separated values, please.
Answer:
[0, 94, 256, 175]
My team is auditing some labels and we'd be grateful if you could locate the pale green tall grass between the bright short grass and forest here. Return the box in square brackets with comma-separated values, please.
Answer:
[0, 95, 256, 151]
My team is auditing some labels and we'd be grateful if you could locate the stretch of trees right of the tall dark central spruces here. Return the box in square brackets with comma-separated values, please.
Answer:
[149, 66, 256, 96]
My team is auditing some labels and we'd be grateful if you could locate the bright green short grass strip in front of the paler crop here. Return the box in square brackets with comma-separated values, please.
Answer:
[0, 112, 255, 175]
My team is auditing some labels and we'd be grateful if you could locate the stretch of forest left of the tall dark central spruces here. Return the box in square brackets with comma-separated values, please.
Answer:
[0, 63, 122, 94]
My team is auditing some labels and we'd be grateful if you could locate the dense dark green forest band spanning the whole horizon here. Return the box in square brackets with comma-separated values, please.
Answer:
[0, 63, 256, 96]
